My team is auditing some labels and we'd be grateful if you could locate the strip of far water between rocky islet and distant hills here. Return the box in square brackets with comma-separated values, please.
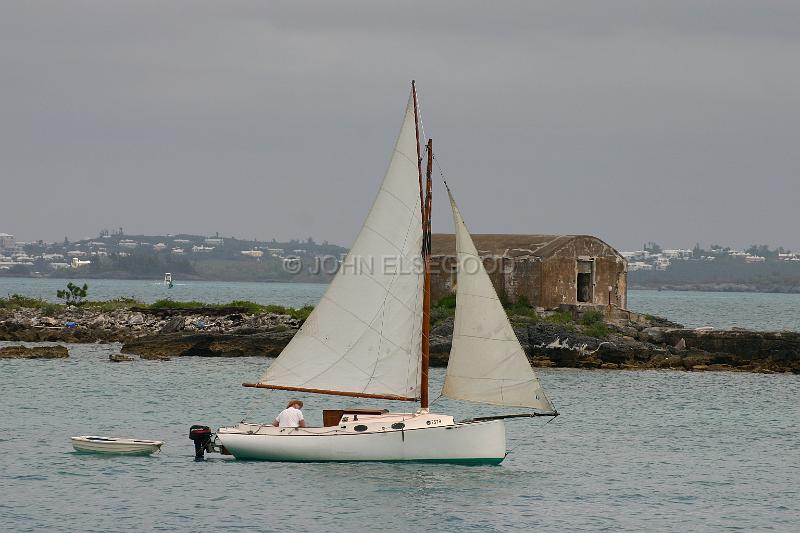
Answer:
[0, 278, 800, 331]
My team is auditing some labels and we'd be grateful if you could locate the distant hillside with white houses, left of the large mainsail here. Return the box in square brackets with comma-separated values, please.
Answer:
[0, 234, 347, 282]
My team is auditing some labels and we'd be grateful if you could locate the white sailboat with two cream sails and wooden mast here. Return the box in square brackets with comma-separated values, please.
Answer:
[216, 82, 558, 464]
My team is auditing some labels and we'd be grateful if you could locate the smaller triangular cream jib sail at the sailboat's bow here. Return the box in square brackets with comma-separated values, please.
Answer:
[442, 189, 555, 413]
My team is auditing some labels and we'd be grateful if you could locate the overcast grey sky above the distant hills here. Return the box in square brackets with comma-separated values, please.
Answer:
[0, 0, 800, 249]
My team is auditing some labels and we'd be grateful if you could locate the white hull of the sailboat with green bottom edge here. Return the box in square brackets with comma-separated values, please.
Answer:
[217, 414, 506, 464]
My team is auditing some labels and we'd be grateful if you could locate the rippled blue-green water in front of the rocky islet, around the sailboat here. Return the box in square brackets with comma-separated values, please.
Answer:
[0, 345, 800, 531]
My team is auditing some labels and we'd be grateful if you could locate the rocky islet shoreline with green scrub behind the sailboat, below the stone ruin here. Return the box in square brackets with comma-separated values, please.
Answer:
[0, 307, 800, 373]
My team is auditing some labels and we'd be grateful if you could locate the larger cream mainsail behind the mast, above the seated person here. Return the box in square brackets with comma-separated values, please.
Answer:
[260, 94, 423, 399]
